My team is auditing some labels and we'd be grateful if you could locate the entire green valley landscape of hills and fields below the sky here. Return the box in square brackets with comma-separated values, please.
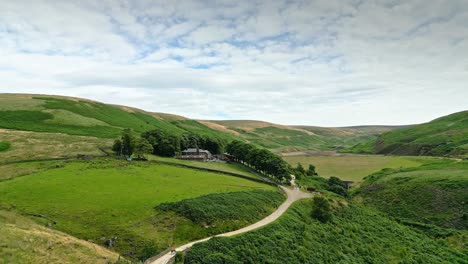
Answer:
[0, 94, 468, 264]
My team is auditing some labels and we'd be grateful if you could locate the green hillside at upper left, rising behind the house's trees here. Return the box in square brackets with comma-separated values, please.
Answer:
[0, 94, 231, 141]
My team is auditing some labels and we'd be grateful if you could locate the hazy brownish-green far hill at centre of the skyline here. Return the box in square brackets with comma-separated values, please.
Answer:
[200, 120, 395, 152]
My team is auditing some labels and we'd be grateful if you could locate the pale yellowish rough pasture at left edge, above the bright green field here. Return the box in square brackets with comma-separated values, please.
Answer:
[0, 129, 112, 163]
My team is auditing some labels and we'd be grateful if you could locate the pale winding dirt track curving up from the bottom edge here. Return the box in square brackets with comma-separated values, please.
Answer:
[145, 176, 313, 264]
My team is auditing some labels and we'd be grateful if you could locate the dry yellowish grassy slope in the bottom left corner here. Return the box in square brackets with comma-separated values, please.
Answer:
[0, 210, 120, 264]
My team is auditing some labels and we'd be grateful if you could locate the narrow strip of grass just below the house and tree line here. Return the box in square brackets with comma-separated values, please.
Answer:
[147, 155, 260, 178]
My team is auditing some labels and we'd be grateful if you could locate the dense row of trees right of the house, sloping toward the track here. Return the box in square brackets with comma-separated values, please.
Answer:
[226, 140, 291, 182]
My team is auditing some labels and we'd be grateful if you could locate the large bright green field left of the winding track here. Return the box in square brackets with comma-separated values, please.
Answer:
[0, 159, 278, 259]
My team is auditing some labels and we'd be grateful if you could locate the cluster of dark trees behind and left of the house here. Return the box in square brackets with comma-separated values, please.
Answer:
[112, 129, 226, 157]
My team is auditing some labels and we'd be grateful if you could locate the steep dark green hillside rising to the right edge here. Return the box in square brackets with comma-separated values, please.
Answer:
[346, 111, 468, 156]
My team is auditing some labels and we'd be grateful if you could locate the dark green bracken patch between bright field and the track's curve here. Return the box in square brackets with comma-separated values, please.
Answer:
[156, 190, 284, 230]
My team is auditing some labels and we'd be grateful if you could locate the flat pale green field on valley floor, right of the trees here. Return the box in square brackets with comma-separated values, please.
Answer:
[283, 156, 437, 182]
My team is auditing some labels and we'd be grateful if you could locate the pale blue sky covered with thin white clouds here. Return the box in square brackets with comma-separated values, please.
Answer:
[0, 0, 468, 126]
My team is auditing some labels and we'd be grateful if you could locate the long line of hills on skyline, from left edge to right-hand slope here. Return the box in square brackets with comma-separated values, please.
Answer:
[0, 94, 402, 152]
